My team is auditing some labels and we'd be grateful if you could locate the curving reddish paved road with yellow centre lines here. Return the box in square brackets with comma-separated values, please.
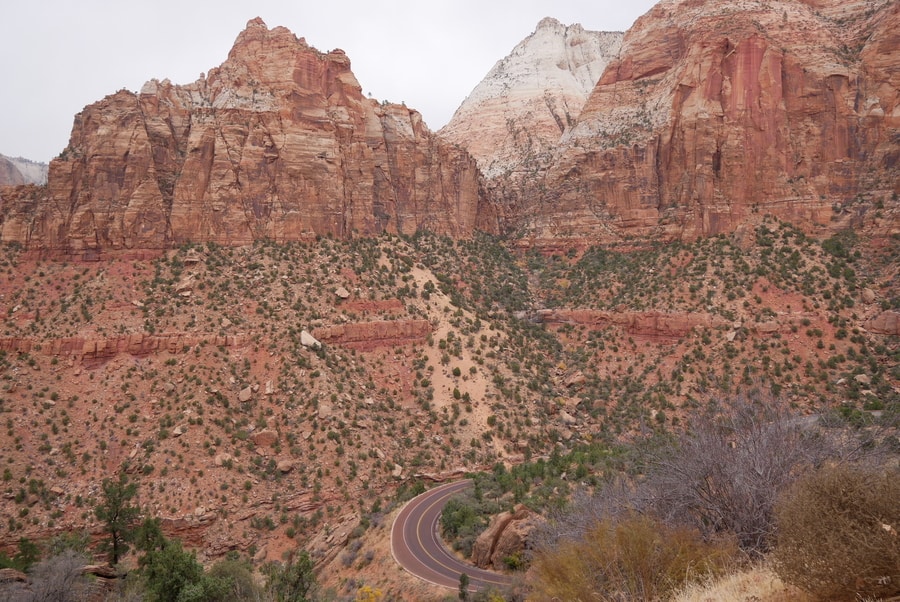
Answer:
[391, 481, 512, 591]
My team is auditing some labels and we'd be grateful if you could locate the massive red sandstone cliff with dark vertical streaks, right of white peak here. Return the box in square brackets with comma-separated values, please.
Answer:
[517, 0, 900, 243]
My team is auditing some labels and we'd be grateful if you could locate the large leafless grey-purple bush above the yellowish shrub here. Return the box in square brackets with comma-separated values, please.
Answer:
[637, 397, 836, 554]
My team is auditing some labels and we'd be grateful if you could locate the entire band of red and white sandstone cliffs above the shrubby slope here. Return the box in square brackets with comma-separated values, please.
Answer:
[0, 0, 900, 253]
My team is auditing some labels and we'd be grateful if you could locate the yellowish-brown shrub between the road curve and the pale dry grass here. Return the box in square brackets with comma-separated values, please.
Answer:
[532, 514, 738, 602]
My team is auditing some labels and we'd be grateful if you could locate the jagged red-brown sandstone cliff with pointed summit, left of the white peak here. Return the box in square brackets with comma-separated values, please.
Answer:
[2, 19, 492, 252]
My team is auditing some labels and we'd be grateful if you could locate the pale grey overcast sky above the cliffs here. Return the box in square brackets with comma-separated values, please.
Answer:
[0, 0, 655, 162]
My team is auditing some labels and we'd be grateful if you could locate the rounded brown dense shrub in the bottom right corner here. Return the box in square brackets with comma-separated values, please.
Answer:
[773, 464, 900, 600]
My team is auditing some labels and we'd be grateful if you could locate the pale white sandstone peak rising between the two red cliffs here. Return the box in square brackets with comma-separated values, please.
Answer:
[440, 17, 623, 179]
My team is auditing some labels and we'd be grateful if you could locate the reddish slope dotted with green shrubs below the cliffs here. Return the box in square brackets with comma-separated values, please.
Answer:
[0, 220, 900, 591]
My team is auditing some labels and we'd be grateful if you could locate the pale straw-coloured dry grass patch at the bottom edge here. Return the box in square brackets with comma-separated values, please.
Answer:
[673, 567, 815, 602]
